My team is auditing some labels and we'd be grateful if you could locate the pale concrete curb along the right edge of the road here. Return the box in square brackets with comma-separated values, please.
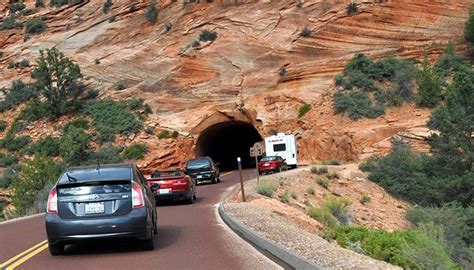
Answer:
[218, 202, 324, 270]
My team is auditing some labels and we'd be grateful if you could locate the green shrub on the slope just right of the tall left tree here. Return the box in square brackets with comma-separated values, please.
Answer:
[86, 99, 142, 143]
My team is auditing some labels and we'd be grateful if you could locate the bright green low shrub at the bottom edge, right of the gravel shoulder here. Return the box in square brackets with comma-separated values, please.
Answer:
[328, 226, 458, 269]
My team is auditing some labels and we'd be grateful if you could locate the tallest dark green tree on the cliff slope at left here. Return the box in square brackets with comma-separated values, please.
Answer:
[32, 48, 82, 118]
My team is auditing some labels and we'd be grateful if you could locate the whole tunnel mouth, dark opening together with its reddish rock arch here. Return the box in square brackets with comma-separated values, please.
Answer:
[191, 110, 263, 170]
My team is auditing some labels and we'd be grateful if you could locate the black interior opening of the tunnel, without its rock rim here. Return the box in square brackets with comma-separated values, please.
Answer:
[196, 121, 262, 171]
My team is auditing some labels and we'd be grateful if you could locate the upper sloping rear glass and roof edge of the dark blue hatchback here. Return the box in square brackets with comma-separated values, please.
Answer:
[58, 163, 135, 184]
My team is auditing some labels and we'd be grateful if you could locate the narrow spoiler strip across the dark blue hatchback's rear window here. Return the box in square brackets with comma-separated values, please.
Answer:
[58, 183, 131, 196]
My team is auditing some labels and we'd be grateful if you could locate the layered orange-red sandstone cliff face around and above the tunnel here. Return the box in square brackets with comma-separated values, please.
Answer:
[0, 0, 472, 170]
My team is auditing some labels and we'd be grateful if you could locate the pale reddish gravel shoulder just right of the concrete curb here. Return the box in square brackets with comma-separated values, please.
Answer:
[224, 168, 401, 269]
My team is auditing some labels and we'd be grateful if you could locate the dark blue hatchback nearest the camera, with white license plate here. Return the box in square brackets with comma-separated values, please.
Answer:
[45, 164, 159, 255]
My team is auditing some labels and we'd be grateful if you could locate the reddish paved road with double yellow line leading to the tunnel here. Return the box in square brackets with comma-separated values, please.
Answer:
[0, 171, 279, 270]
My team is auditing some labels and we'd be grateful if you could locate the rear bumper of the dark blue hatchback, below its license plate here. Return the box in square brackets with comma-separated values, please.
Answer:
[45, 208, 153, 244]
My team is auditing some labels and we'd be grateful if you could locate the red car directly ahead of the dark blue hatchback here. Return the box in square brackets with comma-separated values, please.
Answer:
[147, 170, 196, 204]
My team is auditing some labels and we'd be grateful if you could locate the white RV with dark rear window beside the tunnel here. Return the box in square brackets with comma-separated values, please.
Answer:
[265, 133, 298, 167]
